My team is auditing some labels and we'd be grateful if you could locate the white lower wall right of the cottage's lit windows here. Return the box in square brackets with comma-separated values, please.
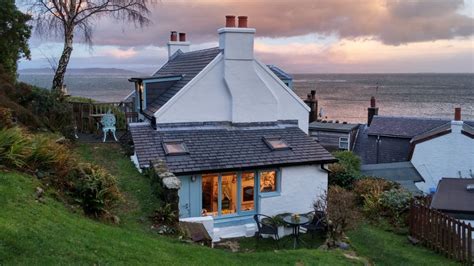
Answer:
[259, 165, 328, 216]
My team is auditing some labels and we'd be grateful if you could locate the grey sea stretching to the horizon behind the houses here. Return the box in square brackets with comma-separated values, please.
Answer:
[19, 71, 474, 123]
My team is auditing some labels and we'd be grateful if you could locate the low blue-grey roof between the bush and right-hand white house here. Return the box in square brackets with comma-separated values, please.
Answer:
[360, 162, 424, 194]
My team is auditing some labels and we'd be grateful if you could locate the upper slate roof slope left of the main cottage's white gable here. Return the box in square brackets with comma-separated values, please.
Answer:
[144, 47, 221, 116]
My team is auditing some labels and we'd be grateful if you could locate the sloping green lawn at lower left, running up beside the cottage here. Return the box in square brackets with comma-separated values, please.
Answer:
[0, 145, 360, 265]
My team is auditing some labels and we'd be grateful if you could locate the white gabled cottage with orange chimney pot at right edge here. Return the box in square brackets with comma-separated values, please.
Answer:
[409, 108, 474, 193]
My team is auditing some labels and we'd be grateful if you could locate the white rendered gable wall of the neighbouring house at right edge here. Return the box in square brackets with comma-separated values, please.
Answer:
[411, 121, 474, 193]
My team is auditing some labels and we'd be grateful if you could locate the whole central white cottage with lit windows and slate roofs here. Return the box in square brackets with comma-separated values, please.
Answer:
[130, 16, 336, 240]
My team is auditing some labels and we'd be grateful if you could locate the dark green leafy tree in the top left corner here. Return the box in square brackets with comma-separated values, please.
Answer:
[0, 0, 31, 80]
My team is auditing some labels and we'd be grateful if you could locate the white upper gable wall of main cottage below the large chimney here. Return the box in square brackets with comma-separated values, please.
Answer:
[155, 55, 309, 133]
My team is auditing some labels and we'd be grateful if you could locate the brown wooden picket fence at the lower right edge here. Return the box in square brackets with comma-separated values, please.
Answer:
[409, 201, 474, 265]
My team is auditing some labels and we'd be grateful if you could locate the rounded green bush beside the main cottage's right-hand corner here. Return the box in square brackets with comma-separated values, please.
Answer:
[328, 151, 360, 188]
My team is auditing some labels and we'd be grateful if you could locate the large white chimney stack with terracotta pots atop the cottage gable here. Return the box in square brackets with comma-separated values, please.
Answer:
[217, 16, 255, 60]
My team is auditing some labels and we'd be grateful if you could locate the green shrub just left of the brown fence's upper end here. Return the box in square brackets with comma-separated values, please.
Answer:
[380, 188, 413, 227]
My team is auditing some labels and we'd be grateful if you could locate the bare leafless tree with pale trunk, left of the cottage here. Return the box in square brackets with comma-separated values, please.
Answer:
[24, 0, 153, 92]
